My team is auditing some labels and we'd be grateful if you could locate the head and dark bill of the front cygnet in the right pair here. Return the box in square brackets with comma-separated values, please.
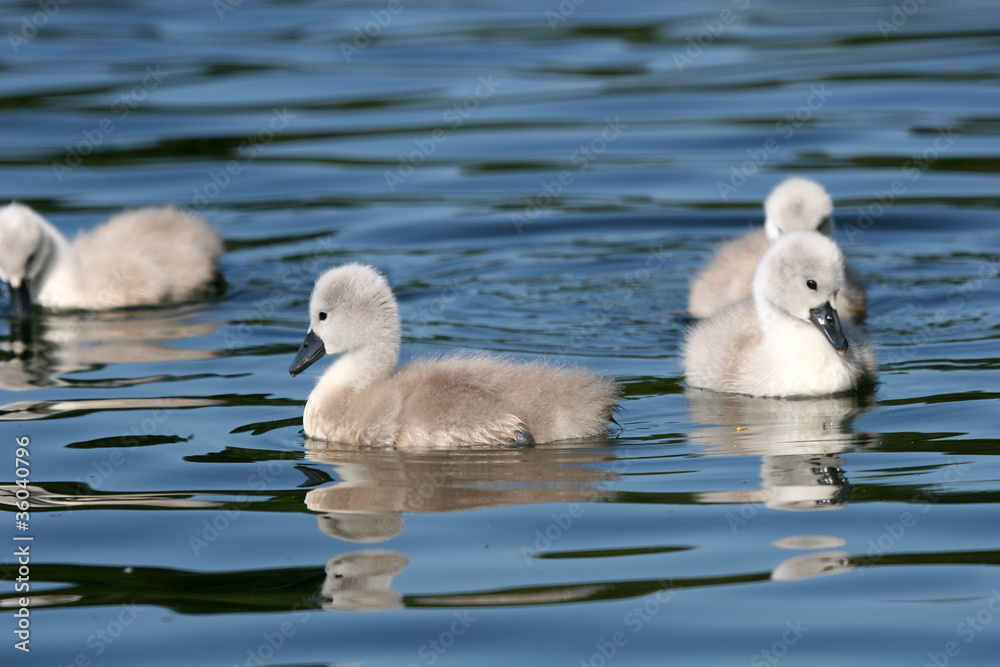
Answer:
[753, 231, 847, 354]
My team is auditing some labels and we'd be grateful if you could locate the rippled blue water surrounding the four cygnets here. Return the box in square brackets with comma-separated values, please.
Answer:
[0, 0, 1000, 667]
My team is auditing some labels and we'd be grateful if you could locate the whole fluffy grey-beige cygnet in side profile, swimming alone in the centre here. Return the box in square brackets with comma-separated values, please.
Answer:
[289, 263, 618, 449]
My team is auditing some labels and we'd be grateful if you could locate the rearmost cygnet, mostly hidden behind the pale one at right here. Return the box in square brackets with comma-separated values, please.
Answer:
[688, 177, 867, 322]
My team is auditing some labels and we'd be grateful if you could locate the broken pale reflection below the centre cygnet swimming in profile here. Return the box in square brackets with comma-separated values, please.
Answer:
[306, 438, 615, 610]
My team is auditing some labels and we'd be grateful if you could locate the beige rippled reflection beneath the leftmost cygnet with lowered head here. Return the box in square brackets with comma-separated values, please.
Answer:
[0, 304, 222, 391]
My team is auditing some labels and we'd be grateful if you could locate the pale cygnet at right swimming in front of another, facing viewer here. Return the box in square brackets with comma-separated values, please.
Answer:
[683, 231, 875, 396]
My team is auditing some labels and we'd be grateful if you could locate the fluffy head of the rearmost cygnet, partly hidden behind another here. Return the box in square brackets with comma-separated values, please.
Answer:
[764, 177, 833, 243]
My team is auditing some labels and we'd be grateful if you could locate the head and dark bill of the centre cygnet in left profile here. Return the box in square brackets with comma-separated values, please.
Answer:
[288, 262, 399, 376]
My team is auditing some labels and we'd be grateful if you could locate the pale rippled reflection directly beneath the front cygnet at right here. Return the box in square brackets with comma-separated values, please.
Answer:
[685, 389, 876, 510]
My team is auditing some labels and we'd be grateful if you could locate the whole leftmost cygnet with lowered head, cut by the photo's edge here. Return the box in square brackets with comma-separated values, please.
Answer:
[0, 202, 224, 315]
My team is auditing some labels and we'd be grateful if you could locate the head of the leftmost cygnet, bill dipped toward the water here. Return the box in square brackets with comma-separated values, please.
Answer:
[0, 202, 54, 316]
